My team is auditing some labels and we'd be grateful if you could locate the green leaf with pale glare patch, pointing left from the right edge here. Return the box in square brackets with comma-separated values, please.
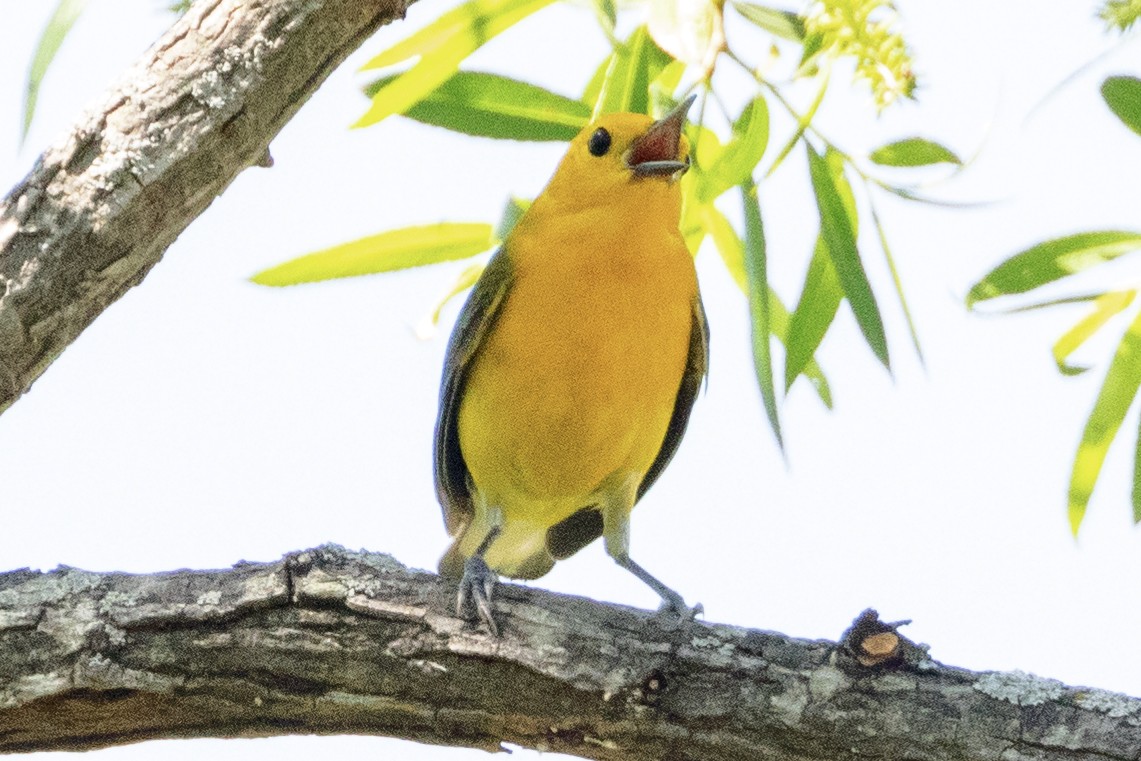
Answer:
[966, 230, 1141, 308]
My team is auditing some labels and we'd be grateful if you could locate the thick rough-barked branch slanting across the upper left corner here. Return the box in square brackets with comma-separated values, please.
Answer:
[0, 0, 411, 412]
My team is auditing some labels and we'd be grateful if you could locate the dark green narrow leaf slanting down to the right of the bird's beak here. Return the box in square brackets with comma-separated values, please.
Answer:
[806, 143, 891, 372]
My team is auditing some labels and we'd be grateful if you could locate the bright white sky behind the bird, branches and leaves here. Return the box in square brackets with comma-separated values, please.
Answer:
[0, 0, 1141, 761]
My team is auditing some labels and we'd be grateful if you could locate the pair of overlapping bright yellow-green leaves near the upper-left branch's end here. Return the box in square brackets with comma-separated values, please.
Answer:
[353, 0, 553, 127]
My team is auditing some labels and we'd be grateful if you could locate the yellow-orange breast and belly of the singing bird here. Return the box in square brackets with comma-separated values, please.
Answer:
[459, 199, 697, 525]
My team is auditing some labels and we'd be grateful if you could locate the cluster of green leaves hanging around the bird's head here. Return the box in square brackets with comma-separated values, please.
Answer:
[253, 0, 961, 456]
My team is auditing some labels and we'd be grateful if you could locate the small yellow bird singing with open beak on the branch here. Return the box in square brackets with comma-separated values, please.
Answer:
[435, 97, 709, 633]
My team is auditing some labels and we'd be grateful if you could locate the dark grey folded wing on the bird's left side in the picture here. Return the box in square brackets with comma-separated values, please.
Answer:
[435, 248, 511, 535]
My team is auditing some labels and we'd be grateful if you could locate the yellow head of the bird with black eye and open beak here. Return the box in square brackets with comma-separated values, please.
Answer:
[536, 96, 696, 214]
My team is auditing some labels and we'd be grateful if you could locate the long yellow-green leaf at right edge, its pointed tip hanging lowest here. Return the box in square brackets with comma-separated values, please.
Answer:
[1069, 311, 1141, 535]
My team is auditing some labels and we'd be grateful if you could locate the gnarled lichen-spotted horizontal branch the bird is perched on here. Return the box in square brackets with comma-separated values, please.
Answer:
[0, 547, 1141, 761]
